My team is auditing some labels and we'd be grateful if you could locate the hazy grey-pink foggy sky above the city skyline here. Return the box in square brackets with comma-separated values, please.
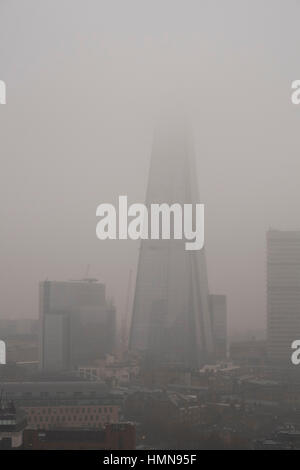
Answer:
[0, 0, 300, 338]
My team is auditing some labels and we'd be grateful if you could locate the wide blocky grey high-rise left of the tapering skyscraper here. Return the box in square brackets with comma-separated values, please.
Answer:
[39, 279, 116, 371]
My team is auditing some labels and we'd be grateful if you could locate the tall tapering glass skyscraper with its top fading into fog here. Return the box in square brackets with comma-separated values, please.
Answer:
[130, 120, 213, 367]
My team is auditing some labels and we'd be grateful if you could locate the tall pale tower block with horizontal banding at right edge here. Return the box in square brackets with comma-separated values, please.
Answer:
[267, 230, 300, 366]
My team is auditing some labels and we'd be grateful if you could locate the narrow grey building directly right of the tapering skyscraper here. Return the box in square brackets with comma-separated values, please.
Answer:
[209, 294, 227, 359]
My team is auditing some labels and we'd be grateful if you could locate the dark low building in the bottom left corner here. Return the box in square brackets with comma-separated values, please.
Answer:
[0, 399, 27, 450]
